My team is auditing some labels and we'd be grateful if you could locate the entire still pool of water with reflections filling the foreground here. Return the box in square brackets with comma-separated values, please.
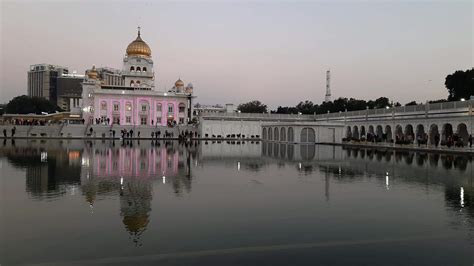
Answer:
[0, 140, 474, 265]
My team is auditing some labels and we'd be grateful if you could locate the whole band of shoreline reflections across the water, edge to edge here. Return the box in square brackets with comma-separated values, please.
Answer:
[0, 141, 474, 256]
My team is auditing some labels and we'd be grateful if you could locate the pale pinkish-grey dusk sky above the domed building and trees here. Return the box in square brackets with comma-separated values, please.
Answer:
[0, 0, 474, 108]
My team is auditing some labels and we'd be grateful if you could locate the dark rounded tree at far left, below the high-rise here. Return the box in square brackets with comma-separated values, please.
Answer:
[6, 95, 62, 114]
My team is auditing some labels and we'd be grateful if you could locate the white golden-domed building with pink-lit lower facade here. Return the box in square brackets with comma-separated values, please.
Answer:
[82, 29, 193, 126]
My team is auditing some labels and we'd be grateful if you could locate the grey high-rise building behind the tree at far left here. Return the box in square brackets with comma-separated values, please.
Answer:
[28, 64, 69, 103]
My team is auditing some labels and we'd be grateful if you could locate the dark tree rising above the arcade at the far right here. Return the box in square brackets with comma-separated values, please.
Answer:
[444, 68, 474, 101]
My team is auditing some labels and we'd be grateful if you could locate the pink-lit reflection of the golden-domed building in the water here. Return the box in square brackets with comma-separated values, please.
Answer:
[81, 141, 197, 246]
